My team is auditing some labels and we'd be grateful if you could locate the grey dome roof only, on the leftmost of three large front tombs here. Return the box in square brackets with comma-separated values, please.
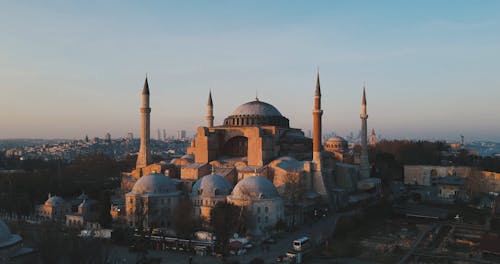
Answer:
[132, 173, 177, 194]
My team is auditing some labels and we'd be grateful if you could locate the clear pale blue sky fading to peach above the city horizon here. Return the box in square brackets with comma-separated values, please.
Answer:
[0, 0, 500, 141]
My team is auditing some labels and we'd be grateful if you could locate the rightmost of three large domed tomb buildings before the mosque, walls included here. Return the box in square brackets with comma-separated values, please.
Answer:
[227, 176, 284, 236]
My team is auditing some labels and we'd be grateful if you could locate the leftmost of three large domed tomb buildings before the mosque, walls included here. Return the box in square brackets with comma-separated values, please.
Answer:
[125, 173, 181, 228]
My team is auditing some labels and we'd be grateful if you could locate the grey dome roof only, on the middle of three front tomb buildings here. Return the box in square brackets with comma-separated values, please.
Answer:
[191, 174, 233, 196]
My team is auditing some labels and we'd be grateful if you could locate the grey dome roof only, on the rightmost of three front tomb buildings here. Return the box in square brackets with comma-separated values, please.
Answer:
[231, 176, 279, 200]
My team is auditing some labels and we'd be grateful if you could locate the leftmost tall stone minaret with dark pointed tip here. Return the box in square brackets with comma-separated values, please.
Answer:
[135, 77, 152, 169]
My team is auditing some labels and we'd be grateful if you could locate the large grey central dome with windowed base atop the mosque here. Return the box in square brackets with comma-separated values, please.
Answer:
[224, 98, 289, 127]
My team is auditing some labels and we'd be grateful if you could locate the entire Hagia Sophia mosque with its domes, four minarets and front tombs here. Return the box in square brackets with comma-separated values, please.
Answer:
[116, 73, 380, 237]
